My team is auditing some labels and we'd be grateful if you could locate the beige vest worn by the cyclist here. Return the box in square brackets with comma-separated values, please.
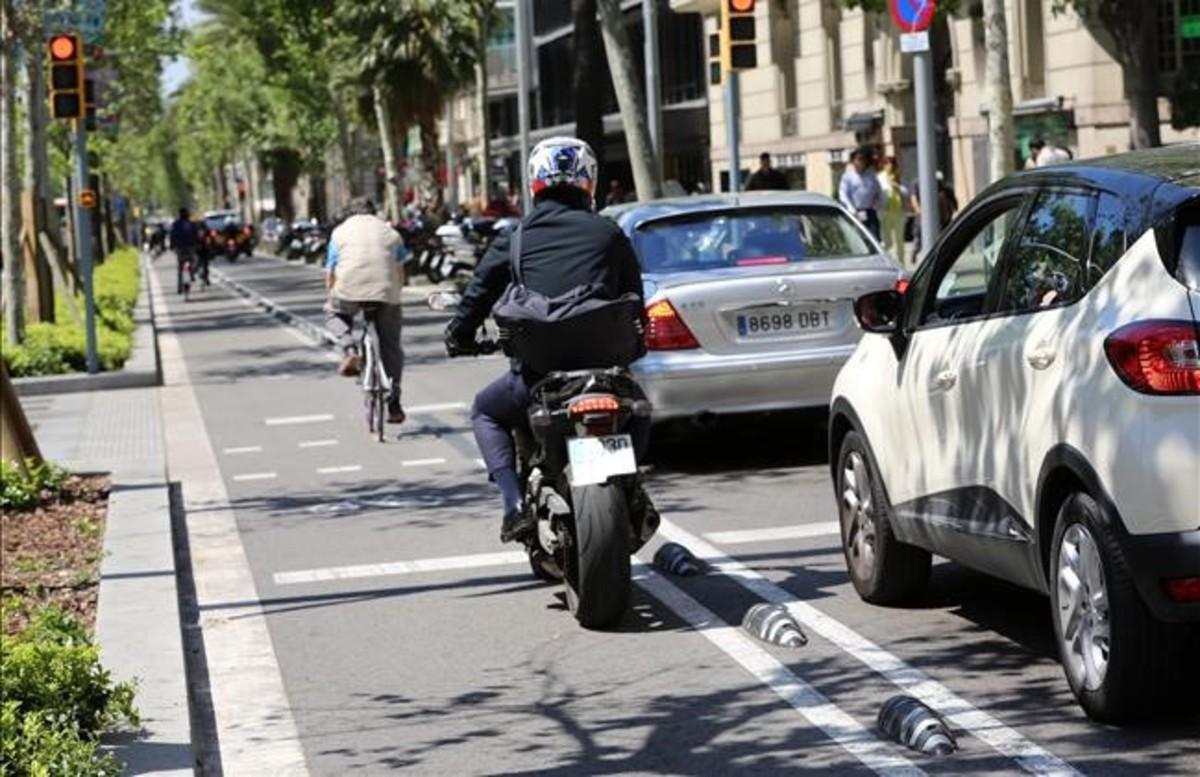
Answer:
[330, 215, 403, 305]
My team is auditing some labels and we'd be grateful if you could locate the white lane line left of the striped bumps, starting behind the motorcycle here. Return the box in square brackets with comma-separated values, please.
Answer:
[634, 561, 925, 777]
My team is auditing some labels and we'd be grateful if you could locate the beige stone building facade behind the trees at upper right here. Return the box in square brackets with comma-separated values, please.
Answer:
[671, 0, 1200, 201]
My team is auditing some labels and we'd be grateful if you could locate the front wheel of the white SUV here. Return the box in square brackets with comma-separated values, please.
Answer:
[838, 432, 931, 604]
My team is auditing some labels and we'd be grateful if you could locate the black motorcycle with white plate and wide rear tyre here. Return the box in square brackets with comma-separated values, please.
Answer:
[428, 291, 658, 628]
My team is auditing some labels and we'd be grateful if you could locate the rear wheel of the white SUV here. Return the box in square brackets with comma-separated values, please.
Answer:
[1050, 493, 1182, 723]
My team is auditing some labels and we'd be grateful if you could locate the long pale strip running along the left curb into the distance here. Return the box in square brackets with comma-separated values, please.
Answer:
[150, 264, 308, 776]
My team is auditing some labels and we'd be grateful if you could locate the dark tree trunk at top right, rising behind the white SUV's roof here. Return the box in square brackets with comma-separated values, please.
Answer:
[1054, 0, 1163, 149]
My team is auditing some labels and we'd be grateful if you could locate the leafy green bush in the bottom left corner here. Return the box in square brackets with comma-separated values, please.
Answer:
[0, 607, 138, 777]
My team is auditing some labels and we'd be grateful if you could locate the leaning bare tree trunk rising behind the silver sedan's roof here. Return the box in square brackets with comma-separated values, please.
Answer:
[596, 0, 662, 200]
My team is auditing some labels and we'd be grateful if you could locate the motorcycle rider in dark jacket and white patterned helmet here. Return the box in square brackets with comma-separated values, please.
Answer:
[445, 138, 653, 542]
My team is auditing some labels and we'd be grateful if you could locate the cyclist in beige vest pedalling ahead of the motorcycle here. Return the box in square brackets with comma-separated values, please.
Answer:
[325, 200, 408, 423]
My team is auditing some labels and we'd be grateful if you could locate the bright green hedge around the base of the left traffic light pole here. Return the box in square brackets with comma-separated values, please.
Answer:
[0, 248, 139, 378]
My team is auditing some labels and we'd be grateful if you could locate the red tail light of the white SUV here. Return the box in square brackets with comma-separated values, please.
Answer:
[1104, 320, 1200, 394]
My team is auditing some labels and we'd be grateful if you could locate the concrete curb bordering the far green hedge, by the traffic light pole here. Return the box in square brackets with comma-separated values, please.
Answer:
[12, 255, 162, 397]
